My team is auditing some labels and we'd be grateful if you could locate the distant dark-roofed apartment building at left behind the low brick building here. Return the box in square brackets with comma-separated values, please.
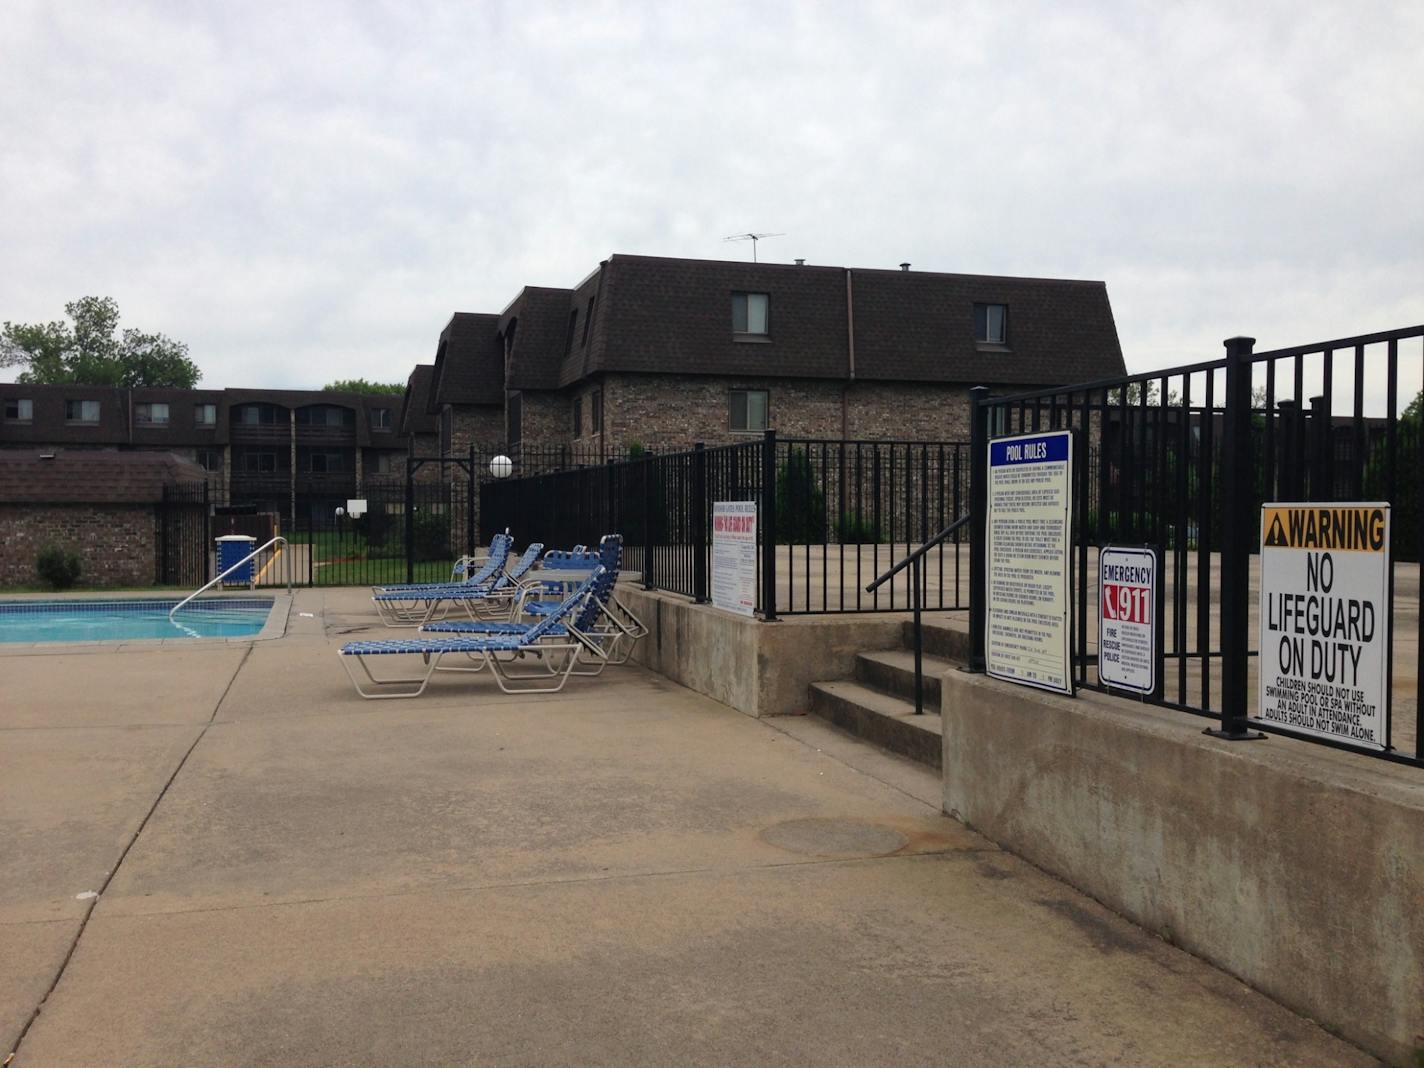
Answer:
[0, 384, 410, 517]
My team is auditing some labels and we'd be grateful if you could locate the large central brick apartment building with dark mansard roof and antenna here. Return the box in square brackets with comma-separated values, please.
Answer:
[415, 255, 1124, 457]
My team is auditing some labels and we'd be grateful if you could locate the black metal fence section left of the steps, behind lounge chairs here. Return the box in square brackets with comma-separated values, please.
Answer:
[480, 431, 968, 618]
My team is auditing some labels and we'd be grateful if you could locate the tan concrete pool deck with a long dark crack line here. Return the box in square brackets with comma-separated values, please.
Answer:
[0, 590, 1373, 1067]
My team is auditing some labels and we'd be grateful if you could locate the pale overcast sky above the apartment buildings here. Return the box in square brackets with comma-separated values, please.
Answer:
[0, 0, 1424, 387]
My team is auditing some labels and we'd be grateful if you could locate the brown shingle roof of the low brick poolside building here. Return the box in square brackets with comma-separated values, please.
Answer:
[0, 449, 206, 504]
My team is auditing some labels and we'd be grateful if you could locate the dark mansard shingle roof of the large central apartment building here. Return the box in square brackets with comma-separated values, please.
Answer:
[561, 255, 1124, 387]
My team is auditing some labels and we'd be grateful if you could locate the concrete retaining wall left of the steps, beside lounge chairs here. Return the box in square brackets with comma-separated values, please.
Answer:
[618, 582, 903, 716]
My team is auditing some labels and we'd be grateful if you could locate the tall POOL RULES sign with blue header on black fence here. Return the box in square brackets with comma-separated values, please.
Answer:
[984, 430, 1072, 695]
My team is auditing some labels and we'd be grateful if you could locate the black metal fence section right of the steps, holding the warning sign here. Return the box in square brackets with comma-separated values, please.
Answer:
[971, 326, 1424, 765]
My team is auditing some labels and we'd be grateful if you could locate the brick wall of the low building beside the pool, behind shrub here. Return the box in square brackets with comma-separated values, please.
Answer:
[0, 504, 157, 587]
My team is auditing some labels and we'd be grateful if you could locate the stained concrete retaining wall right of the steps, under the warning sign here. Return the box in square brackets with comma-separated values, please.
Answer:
[943, 672, 1424, 1064]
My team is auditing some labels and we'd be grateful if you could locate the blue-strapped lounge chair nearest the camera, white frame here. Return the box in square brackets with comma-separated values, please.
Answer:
[337, 568, 602, 701]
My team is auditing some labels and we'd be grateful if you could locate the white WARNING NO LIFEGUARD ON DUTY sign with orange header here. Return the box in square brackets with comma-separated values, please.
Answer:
[1257, 504, 1390, 749]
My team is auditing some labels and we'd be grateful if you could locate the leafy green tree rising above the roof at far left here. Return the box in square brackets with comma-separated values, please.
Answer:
[0, 296, 201, 389]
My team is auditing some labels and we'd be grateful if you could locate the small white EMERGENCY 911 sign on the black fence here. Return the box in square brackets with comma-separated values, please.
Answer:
[1098, 545, 1162, 696]
